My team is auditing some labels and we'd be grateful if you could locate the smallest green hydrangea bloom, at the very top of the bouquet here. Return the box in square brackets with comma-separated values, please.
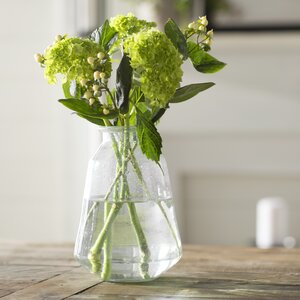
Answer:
[110, 13, 156, 38]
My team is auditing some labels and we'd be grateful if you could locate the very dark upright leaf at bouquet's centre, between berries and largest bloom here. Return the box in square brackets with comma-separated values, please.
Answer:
[116, 53, 132, 114]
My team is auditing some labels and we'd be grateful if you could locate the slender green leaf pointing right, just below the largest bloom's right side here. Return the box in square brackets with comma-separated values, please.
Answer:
[169, 82, 215, 103]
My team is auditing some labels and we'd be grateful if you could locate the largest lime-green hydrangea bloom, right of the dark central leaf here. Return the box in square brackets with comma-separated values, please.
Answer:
[124, 29, 183, 107]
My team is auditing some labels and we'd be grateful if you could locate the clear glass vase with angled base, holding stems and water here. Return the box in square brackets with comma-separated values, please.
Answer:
[74, 127, 181, 282]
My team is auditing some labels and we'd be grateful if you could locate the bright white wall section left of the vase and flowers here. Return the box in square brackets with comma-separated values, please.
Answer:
[0, 0, 92, 241]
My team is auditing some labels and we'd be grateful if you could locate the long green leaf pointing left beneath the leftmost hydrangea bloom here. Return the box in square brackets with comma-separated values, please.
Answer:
[58, 98, 118, 119]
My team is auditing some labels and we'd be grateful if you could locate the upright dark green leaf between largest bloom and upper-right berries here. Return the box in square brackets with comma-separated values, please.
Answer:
[165, 19, 188, 59]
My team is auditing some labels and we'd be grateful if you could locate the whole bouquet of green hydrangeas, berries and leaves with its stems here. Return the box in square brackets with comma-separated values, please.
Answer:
[35, 14, 225, 279]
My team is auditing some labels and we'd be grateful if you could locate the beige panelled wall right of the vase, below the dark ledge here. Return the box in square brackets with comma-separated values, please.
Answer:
[160, 33, 300, 245]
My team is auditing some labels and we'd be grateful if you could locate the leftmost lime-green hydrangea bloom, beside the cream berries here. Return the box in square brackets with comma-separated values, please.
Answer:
[43, 37, 111, 83]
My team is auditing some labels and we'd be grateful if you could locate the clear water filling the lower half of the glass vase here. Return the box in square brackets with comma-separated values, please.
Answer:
[75, 198, 181, 281]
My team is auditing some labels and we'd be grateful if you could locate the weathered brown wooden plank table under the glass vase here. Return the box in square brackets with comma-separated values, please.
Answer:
[0, 243, 300, 300]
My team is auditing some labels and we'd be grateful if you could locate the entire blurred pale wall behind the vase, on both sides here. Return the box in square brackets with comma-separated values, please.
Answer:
[0, 0, 300, 245]
